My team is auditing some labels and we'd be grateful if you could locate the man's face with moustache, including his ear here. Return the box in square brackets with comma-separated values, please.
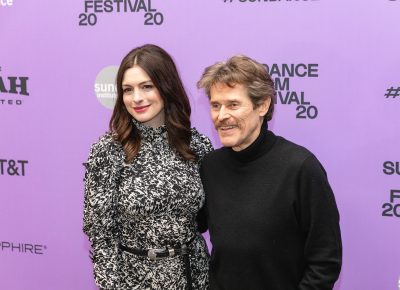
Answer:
[210, 84, 270, 151]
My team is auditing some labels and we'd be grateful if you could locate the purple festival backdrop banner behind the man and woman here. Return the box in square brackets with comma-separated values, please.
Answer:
[0, 0, 400, 290]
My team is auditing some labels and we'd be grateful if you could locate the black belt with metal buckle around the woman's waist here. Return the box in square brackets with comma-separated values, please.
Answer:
[119, 236, 196, 290]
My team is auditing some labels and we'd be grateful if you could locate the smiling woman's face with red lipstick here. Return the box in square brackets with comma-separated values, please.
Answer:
[122, 65, 165, 128]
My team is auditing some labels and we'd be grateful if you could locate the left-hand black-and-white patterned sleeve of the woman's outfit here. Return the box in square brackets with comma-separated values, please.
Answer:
[83, 134, 122, 289]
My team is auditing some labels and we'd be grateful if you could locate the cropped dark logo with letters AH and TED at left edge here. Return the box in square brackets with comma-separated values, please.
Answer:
[0, 66, 29, 105]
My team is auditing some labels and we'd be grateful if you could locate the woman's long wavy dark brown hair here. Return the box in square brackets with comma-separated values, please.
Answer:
[109, 44, 197, 163]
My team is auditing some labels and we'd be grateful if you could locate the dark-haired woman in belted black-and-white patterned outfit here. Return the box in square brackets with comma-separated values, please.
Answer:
[83, 45, 212, 290]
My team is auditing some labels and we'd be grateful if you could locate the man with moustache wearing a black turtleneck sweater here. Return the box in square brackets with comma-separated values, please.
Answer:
[198, 56, 342, 290]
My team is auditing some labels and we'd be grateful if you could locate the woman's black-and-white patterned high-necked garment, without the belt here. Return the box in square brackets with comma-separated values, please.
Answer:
[83, 122, 212, 290]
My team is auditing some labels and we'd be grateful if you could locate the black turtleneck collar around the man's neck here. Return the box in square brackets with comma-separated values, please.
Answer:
[226, 121, 276, 163]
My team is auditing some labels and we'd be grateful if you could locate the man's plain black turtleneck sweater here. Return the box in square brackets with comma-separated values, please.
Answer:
[201, 122, 342, 290]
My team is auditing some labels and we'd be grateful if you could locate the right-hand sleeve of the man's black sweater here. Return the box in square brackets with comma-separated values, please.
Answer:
[298, 155, 342, 290]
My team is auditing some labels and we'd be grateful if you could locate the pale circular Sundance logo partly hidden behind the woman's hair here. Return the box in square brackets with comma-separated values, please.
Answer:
[94, 65, 118, 110]
